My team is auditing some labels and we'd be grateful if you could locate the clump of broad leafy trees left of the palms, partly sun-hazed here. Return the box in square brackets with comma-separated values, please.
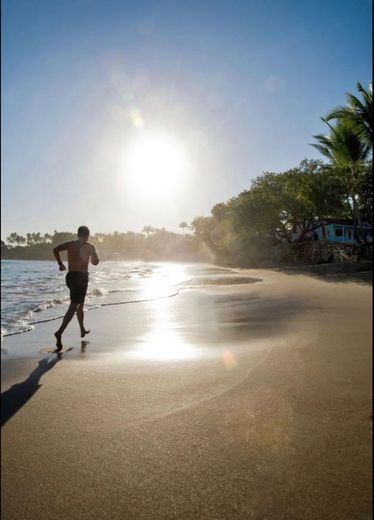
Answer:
[192, 159, 349, 265]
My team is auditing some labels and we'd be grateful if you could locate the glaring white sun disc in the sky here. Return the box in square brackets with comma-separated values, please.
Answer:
[124, 133, 188, 196]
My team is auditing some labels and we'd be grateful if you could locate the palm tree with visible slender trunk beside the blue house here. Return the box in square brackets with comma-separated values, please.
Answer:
[312, 118, 370, 243]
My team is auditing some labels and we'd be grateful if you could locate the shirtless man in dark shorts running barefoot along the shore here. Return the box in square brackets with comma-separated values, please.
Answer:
[53, 226, 99, 351]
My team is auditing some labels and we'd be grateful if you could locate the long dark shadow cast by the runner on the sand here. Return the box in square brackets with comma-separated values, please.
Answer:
[1, 356, 62, 427]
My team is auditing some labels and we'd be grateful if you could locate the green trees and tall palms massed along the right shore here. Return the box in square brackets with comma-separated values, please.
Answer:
[192, 83, 373, 265]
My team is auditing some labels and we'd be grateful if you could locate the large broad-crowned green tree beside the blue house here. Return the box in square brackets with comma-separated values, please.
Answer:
[229, 159, 346, 242]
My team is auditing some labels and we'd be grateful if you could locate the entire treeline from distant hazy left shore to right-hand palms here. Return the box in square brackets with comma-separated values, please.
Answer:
[2, 83, 373, 266]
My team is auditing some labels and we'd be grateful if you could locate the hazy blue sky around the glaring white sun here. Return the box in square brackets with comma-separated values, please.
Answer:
[1, 0, 372, 239]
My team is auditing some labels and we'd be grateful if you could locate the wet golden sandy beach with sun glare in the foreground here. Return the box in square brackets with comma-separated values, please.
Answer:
[2, 266, 372, 520]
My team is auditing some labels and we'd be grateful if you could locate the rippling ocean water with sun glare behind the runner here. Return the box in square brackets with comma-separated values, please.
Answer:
[1, 260, 188, 337]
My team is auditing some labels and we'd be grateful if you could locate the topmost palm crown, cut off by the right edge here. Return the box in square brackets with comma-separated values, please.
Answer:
[325, 83, 373, 148]
